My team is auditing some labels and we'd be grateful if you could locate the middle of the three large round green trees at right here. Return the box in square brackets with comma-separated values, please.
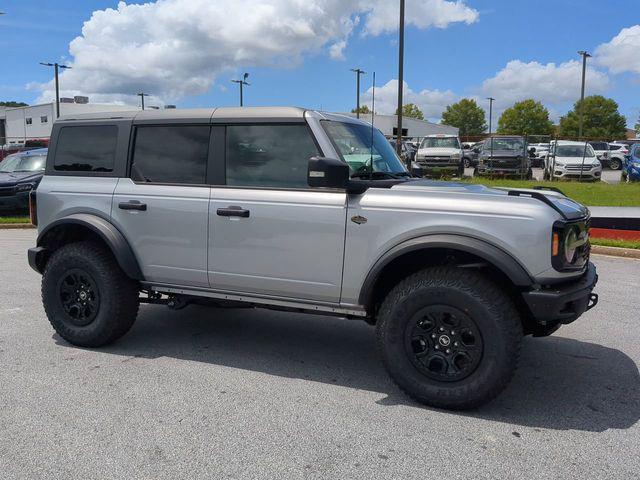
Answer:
[497, 99, 553, 135]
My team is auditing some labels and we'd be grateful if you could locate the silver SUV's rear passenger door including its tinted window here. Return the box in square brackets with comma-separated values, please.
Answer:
[111, 124, 211, 287]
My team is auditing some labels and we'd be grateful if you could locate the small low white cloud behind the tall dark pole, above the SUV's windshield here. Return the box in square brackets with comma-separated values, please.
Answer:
[362, 80, 460, 121]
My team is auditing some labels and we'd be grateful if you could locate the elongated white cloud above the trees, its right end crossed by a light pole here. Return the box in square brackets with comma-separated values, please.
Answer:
[481, 60, 609, 110]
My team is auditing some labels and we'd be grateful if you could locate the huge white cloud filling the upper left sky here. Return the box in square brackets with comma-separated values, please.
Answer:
[30, 0, 478, 103]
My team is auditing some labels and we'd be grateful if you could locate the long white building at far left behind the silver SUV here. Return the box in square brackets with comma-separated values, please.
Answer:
[0, 97, 136, 145]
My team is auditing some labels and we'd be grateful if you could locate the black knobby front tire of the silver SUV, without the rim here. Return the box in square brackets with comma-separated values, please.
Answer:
[377, 267, 523, 410]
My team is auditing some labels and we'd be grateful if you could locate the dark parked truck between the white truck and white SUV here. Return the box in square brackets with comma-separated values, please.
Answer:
[474, 136, 533, 180]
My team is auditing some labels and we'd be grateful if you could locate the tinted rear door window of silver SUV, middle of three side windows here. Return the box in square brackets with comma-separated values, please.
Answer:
[131, 125, 211, 185]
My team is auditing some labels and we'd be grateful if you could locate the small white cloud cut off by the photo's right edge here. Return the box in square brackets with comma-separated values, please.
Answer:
[594, 25, 640, 75]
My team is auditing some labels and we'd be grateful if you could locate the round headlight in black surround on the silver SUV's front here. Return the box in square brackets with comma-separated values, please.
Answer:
[551, 222, 591, 272]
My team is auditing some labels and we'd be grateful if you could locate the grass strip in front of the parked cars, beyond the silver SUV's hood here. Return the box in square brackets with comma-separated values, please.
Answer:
[465, 178, 640, 207]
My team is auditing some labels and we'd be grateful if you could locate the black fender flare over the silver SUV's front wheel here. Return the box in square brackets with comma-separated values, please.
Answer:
[358, 234, 535, 305]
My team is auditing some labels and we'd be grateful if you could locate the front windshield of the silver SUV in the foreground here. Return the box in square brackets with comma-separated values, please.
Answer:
[322, 121, 409, 178]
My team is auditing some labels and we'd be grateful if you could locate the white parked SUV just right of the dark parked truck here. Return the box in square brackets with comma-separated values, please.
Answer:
[544, 140, 602, 181]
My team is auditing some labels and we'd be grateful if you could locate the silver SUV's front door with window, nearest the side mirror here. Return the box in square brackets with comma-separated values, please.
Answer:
[208, 123, 346, 303]
